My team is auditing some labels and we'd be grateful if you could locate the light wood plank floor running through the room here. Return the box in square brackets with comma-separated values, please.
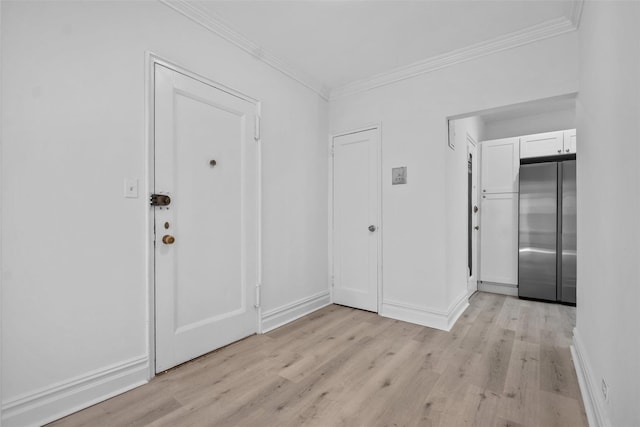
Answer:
[54, 293, 587, 427]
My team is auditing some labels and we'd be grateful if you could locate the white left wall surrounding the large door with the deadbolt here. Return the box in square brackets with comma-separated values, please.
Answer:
[2, 1, 328, 425]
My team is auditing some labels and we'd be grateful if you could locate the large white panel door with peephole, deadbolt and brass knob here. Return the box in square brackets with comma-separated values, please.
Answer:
[152, 64, 258, 372]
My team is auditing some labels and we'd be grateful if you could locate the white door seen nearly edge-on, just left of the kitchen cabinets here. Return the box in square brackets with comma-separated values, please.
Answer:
[467, 140, 480, 296]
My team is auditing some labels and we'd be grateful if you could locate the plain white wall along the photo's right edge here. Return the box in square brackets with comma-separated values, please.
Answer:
[575, 2, 640, 426]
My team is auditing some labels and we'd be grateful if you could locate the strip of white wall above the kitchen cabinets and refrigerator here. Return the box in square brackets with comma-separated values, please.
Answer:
[485, 108, 576, 140]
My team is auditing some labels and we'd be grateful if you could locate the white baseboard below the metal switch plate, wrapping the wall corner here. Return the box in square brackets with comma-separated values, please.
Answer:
[380, 291, 469, 332]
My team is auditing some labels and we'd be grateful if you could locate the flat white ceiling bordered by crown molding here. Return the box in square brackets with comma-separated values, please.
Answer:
[190, 0, 573, 89]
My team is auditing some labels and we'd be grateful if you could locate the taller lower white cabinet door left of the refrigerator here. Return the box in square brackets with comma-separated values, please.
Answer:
[480, 193, 518, 285]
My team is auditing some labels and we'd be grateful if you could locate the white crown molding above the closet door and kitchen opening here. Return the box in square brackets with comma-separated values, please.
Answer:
[329, 15, 582, 101]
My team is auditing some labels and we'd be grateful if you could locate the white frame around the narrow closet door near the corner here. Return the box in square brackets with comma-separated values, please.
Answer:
[328, 123, 384, 314]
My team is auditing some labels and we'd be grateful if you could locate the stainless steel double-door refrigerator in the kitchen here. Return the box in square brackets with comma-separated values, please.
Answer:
[518, 159, 576, 304]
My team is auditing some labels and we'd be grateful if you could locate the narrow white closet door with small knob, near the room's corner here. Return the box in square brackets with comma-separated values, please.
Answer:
[333, 129, 380, 312]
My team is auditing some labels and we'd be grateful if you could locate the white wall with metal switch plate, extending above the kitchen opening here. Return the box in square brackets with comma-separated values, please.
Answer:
[330, 32, 577, 328]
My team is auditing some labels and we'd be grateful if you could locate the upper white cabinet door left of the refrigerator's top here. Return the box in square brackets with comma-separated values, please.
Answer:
[480, 138, 520, 194]
